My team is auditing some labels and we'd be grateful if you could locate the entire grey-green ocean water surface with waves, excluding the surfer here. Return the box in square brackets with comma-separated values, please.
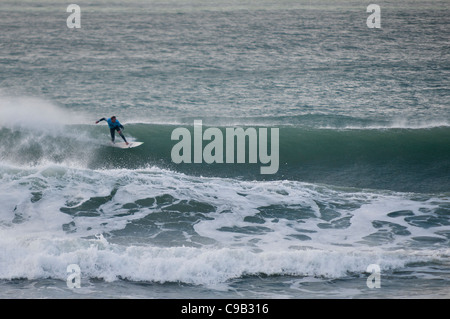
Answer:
[0, 0, 450, 299]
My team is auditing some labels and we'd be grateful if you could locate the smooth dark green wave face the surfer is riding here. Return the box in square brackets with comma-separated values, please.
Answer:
[0, 118, 450, 193]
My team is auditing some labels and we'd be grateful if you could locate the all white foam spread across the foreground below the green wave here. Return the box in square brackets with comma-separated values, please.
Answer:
[0, 165, 449, 285]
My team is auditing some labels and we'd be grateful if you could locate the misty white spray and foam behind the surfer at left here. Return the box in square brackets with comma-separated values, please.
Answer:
[0, 95, 102, 166]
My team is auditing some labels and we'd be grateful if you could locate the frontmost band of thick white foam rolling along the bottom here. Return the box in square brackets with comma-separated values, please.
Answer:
[0, 232, 436, 285]
